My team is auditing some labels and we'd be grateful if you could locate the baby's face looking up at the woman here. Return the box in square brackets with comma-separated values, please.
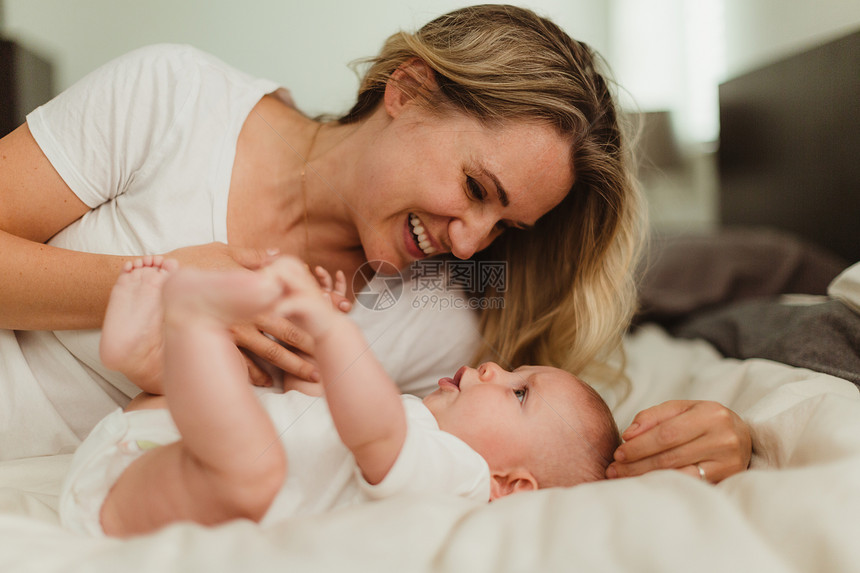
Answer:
[424, 362, 583, 468]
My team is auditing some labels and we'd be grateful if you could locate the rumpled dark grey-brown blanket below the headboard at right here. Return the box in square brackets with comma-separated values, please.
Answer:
[636, 229, 860, 387]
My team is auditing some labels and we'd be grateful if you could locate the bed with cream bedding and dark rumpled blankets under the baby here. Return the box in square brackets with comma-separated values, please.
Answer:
[0, 31, 860, 573]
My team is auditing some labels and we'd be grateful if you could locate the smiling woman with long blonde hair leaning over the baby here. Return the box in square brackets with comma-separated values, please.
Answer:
[0, 6, 744, 474]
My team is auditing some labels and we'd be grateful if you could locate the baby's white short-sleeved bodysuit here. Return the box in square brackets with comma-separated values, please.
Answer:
[59, 391, 490, 535]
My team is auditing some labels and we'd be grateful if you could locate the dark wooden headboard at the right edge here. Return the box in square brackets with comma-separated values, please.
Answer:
[719, 31, 860, 263]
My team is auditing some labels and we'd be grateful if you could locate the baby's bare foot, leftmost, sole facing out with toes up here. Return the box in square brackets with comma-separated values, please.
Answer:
[99, 256, 178, 394]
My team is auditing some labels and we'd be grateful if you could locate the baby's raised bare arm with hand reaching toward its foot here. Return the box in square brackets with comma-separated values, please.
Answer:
[268, 259, 406, 484]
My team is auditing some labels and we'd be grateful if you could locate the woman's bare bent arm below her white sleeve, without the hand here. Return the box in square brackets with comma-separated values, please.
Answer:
[0, 124, 125, 330]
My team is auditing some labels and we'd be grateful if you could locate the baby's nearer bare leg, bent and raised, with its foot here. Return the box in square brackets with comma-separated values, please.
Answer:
[101, 269, 286, 535]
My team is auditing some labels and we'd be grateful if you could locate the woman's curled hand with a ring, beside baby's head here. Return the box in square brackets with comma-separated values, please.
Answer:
[606, 400, 752, 483]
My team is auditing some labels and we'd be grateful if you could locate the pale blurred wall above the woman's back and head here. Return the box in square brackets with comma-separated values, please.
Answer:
[2, 0, 608, 115]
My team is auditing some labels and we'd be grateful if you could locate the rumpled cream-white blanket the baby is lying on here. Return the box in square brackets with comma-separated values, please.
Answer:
[0, 326, 860, 573]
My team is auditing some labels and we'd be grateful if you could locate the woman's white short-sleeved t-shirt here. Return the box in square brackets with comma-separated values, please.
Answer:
[0, 45, 478, 459]
